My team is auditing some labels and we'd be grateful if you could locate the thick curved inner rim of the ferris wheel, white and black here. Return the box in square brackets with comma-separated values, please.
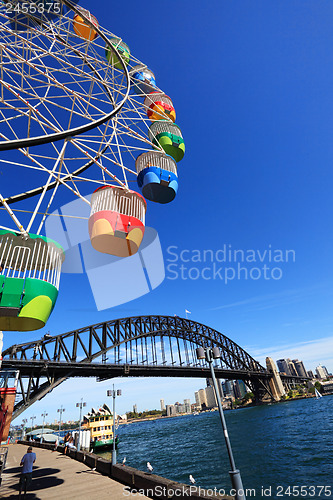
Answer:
[0, 0, 131, 152]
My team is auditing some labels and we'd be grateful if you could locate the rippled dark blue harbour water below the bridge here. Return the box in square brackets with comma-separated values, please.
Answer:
[96, 396, 333, 499]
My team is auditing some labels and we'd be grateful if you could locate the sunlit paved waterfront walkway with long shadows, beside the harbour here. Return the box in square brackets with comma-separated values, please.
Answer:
[0, 444, 148, 500]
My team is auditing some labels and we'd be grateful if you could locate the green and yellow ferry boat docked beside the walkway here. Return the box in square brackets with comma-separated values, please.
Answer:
[83, 404, 119, 452]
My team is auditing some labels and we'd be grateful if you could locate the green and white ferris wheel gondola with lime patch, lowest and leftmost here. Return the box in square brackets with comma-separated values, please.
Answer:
[0, 230, 65, 331]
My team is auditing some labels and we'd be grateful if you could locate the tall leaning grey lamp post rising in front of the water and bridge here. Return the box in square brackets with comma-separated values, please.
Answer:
[196, 347, 246, 500]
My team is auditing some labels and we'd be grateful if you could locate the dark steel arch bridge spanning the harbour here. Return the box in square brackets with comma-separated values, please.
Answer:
[2, 316, 272, 418]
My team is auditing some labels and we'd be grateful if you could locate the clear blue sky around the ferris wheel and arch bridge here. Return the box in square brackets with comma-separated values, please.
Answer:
[5, 0, 333, 423]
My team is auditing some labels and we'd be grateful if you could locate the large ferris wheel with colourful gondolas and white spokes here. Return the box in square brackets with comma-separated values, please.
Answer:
[0, 0, 185, 331]
